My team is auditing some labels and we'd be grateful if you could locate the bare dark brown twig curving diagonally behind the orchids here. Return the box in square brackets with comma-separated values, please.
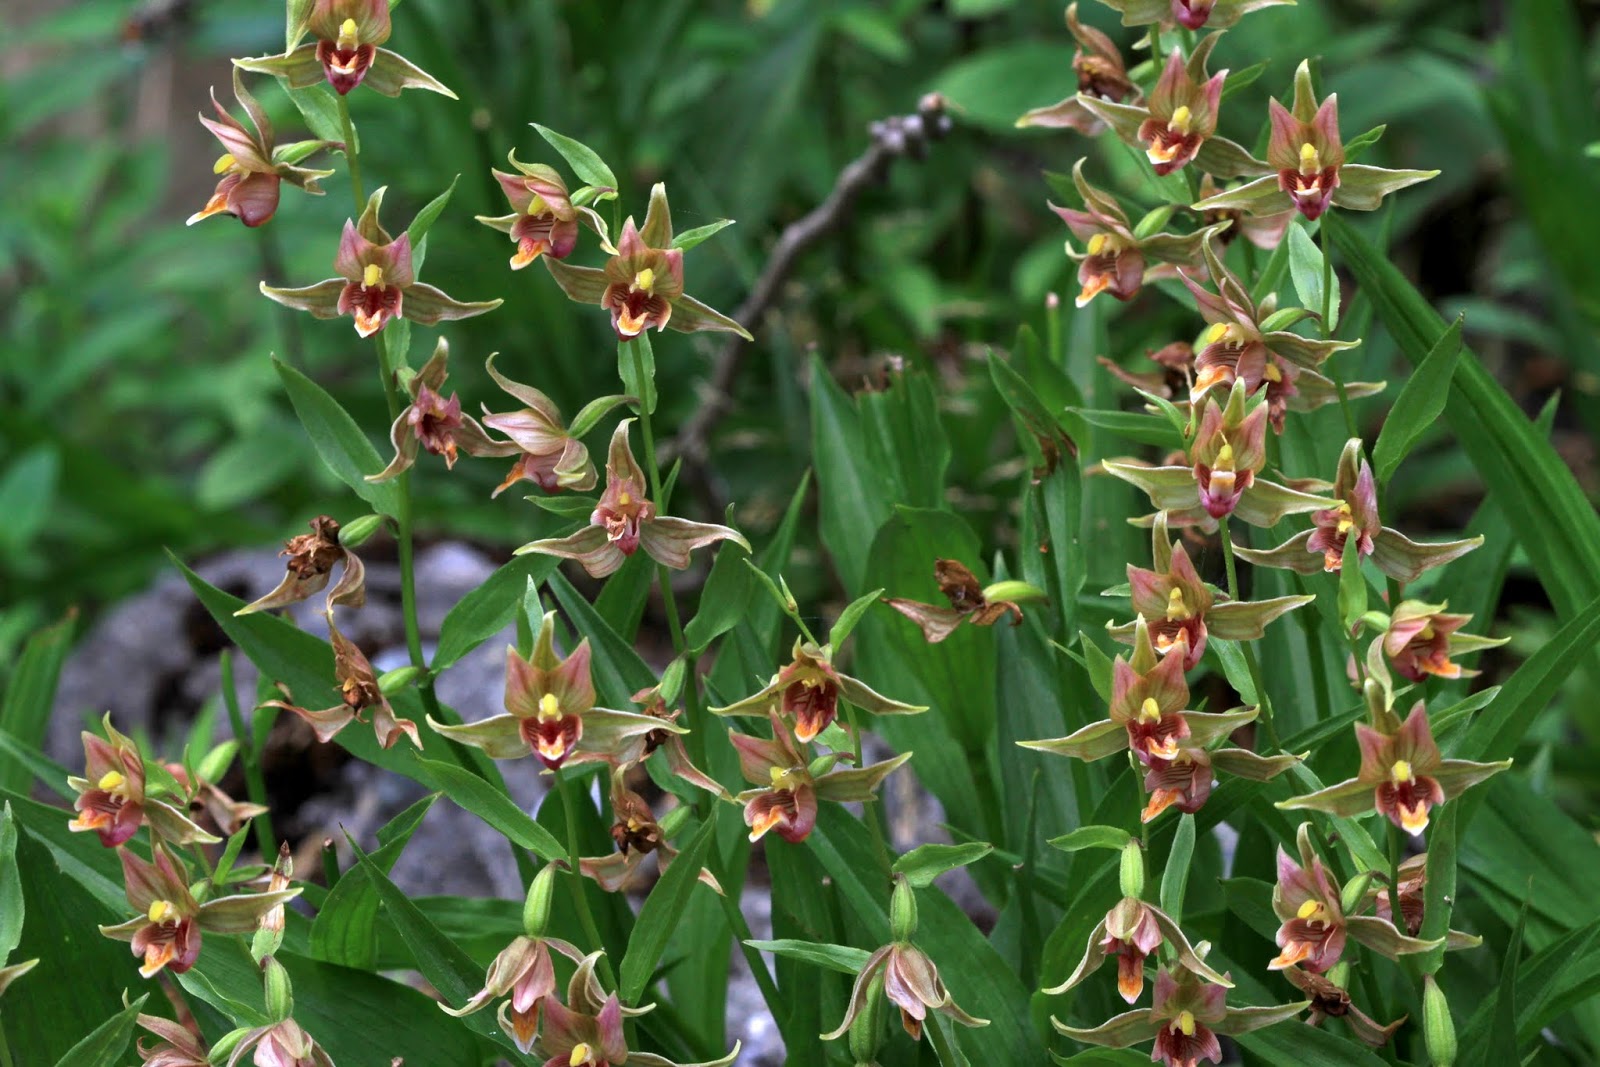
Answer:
[661, 93, 950, 470]
